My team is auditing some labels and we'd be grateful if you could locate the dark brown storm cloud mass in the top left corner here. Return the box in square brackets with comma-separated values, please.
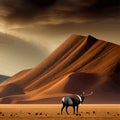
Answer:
[0, 0, 56, 22]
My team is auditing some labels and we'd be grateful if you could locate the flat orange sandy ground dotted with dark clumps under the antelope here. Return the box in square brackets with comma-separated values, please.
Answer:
[0, 104, 120, 120]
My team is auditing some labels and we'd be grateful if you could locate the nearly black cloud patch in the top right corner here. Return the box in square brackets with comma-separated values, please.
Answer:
[90, 0, 120, 17]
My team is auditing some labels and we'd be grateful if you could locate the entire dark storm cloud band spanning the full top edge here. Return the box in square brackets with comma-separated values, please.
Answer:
[0, 0, 120, 23]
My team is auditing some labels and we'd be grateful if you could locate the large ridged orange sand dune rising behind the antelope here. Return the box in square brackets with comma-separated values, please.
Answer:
[0, 35, 120, 104]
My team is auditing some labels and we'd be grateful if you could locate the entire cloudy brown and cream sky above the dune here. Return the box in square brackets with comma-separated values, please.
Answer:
[0, 0, 120, 76]
